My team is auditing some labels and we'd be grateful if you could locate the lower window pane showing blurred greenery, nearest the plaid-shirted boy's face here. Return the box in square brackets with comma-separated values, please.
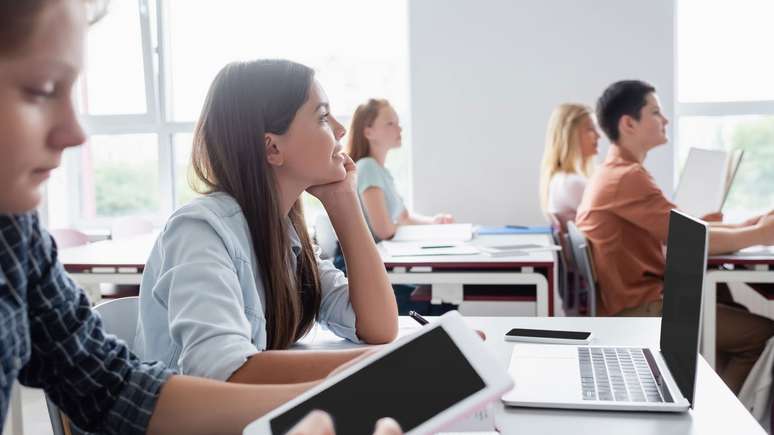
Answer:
[80, 134, 160, 219]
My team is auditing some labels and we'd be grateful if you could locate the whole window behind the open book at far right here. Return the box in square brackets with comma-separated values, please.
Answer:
[675, 0, 774, 222]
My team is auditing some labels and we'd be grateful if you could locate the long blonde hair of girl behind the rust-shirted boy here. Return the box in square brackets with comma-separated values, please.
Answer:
[540, 103, 593, 214]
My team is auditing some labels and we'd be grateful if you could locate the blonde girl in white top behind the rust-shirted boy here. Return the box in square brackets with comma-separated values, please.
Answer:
[540, 103, 599, 228]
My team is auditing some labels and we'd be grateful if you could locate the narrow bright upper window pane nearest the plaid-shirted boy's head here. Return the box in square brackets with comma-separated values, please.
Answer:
[80, 0, 147, 115]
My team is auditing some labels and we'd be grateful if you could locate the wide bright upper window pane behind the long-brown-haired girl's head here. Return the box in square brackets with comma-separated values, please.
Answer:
[168, 0, 408, 121]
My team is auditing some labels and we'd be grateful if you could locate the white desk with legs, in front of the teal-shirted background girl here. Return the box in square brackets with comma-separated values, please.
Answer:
[378, 234, 557, 316]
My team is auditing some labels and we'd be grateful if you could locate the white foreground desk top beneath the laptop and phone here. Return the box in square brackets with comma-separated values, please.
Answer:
[297, 317, 765, 435]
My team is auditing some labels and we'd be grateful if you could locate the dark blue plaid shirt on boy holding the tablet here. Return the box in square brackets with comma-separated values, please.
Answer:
[0, 213, 170, 434]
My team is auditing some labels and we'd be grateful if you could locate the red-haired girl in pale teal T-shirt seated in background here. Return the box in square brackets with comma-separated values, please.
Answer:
[347, 99, 454, 241]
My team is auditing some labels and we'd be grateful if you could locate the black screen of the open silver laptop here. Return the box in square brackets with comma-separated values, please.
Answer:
[661, 210, 707, 407]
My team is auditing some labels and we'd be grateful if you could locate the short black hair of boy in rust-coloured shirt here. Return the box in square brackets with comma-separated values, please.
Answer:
[597, 80, 656, 142]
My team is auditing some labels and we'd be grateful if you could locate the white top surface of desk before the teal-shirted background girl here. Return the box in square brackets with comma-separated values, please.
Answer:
[377, 234, 555, 267]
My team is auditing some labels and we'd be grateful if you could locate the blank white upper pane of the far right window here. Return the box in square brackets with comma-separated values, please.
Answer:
[677, 0, 774, 103]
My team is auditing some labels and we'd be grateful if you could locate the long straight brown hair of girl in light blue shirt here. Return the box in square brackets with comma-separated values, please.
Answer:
[192, 60, 321, 349]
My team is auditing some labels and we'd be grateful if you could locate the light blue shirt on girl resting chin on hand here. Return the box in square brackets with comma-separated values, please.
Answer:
[134, 193, 359, 381]
